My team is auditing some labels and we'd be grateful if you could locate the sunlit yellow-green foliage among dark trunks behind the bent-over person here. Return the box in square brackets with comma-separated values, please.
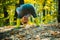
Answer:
[0, 0, 58, 26]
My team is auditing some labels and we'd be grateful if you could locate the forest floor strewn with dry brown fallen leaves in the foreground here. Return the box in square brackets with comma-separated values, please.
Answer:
[0, 23, 60, 40]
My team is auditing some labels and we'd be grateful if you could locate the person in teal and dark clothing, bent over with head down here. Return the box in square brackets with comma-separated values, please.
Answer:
[16, 4, 38, 26]
